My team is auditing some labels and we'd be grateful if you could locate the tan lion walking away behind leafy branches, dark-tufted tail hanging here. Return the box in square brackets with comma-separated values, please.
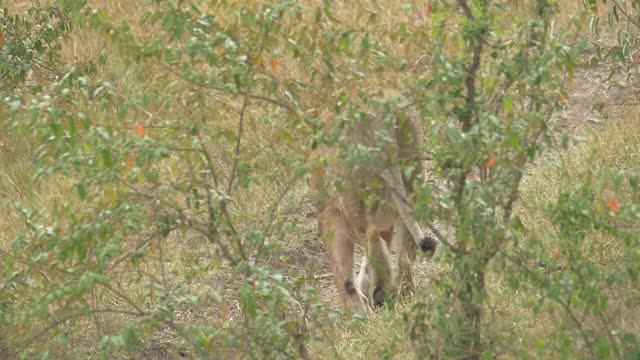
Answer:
[310, 105, 436, 313]
